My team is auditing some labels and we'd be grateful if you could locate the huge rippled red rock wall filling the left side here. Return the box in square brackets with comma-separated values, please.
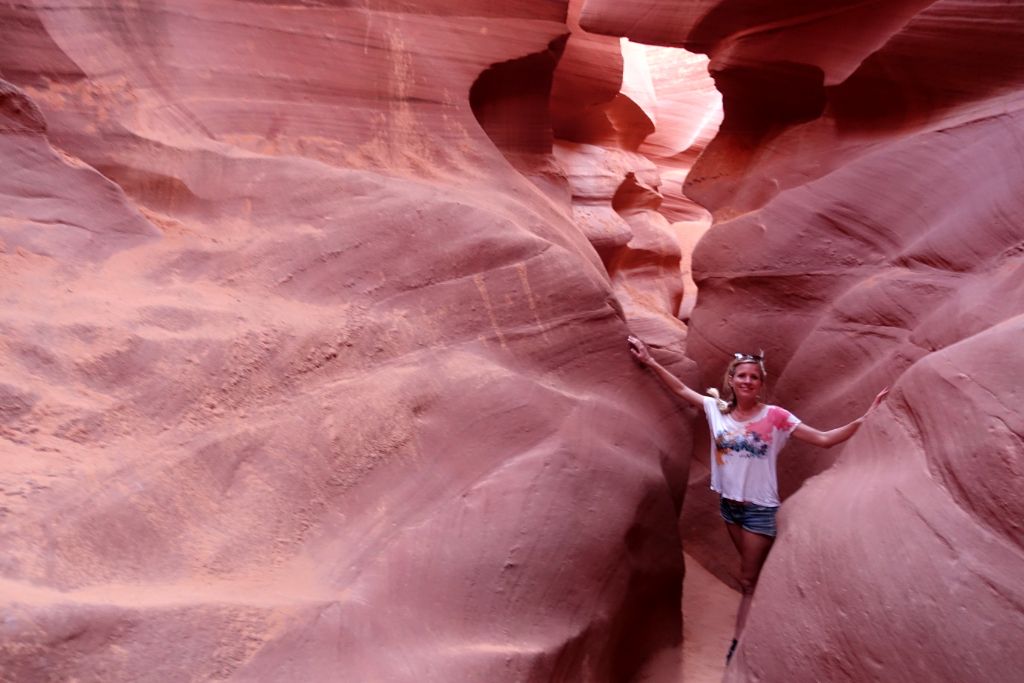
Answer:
[0, 0, 689, 681]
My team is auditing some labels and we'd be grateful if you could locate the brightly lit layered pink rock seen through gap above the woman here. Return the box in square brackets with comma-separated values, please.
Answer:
[552, 0, 721, 329]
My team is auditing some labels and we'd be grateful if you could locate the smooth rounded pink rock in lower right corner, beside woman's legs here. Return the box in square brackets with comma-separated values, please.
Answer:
[741, 325, 1024, 681]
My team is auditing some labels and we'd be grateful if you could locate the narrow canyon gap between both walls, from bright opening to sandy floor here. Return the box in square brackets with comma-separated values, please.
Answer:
[470, 12, 739, 683]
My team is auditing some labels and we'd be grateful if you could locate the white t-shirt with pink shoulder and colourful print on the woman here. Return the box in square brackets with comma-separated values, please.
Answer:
[703, 396, 800, 507]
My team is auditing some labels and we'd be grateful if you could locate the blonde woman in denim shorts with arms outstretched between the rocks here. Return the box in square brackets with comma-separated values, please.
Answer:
[628, 337, 889, 661]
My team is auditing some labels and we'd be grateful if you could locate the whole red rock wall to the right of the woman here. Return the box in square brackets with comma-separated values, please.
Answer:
[581, 0, 1024, 682]
